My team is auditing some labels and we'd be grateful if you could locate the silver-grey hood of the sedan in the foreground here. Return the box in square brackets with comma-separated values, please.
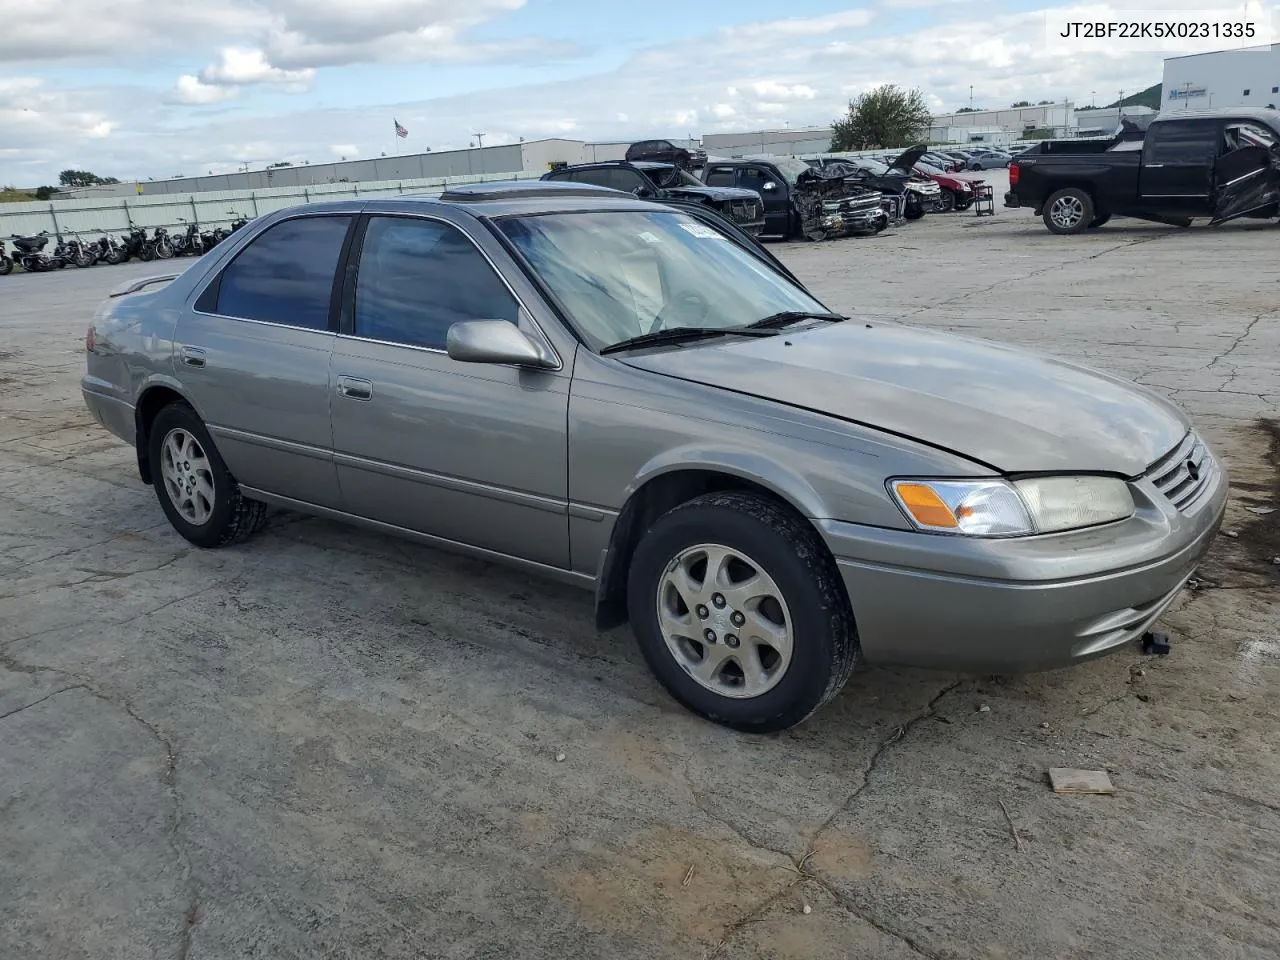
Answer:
[620, 320, 1189, 477]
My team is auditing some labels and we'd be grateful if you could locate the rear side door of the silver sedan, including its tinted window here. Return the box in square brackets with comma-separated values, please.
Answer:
[174, 214, 355, 507]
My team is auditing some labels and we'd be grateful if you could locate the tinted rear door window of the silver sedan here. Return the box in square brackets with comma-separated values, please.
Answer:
[216, 216, 351, 330]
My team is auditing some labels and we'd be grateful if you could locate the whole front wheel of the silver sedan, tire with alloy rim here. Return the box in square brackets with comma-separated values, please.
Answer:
[627, 492, 859, 733]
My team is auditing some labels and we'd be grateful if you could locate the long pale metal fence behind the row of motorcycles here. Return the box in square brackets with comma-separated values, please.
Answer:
[0, 173, 541, 239]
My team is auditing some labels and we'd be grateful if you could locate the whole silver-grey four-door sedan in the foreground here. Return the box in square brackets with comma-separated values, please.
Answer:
[83, 183, 1226, 731]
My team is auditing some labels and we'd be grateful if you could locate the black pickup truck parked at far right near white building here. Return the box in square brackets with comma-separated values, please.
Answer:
[1005, 108, 1280, 233]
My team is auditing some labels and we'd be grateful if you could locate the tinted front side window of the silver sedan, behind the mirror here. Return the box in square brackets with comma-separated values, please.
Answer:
[355, 216, 518, 349]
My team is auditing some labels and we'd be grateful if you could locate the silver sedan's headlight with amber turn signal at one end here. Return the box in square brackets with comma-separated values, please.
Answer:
[888, 476, 1133, 536]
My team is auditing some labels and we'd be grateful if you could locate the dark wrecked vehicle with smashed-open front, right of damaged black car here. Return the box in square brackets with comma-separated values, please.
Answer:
[703, 157, 891, 241]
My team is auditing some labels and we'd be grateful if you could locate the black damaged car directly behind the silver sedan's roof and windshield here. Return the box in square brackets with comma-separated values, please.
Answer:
[541, 160, 764, 237]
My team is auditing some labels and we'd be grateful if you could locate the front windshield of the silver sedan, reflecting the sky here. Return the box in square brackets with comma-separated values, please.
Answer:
[495, 210, 829, 349]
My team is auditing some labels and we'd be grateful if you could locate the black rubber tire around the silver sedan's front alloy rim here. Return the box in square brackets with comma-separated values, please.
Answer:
[627, 506, 844, 731]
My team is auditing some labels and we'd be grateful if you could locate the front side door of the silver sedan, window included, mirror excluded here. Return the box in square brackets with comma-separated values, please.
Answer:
[332, 214, 571, 568]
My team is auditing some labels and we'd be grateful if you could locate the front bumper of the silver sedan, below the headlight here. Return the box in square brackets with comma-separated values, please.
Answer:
[819, 453, 1228, 672]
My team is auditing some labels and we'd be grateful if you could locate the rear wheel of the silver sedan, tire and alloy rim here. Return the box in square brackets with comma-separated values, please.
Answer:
[147, 403, 266, 547]
